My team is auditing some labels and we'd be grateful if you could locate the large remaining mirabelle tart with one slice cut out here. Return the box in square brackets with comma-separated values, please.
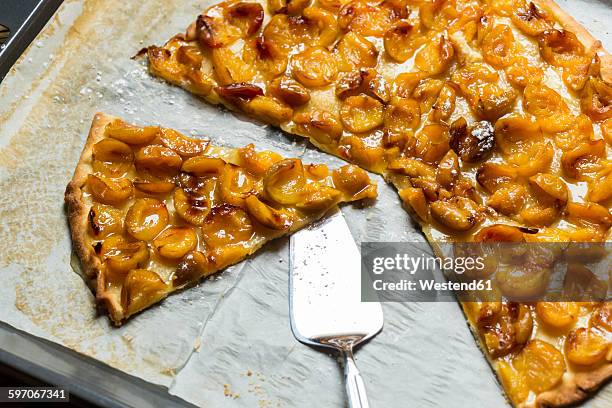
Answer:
[146, 0, 612, 406]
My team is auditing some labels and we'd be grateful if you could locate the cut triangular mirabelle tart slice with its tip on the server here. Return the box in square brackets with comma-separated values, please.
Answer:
[66, 114, 377, 325]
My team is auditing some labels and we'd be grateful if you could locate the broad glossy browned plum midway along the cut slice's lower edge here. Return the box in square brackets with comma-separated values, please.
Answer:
[202, 204, 253, 248]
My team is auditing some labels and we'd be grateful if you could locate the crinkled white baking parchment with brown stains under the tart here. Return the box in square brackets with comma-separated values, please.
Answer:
[0, 0, 612, 407]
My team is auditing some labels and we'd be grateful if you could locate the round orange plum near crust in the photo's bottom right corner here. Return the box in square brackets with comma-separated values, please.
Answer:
[565, 327, 612, 366]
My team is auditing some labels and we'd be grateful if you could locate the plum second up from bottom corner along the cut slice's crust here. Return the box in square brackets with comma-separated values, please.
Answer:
[100, 235, 149, 273]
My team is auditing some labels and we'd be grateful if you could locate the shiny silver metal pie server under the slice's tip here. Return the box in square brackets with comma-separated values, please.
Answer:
[289, 211, 383, 408]
